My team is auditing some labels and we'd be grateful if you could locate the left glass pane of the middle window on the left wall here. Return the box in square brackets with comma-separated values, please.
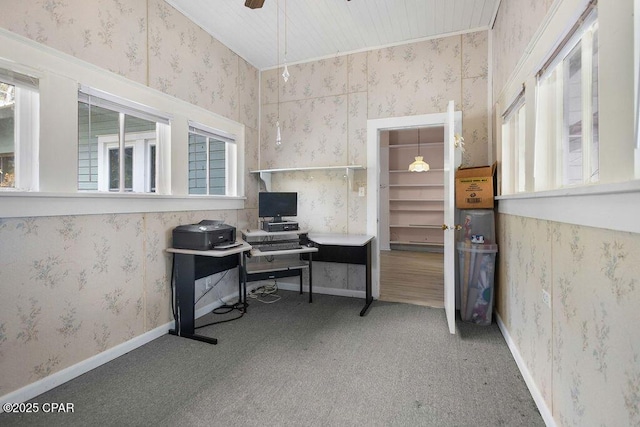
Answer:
[78, 102, 119, 190]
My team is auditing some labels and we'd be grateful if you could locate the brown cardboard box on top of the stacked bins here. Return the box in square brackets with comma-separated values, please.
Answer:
[456, 163, 496, 209]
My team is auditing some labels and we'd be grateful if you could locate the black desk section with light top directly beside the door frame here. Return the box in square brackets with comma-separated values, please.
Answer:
[308, 233, 373, 316]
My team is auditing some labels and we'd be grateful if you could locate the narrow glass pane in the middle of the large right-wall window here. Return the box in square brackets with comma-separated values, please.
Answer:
[563, 44, 583, 185]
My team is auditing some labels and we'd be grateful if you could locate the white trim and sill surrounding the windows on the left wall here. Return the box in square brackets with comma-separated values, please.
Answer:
[0, 28, 245, 218]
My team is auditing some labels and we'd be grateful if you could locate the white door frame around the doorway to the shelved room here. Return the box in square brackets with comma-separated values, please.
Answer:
[367, 111, 462, 326]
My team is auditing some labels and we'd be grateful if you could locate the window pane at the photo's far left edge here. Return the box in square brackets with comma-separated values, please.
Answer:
[0, 81, 16, 188]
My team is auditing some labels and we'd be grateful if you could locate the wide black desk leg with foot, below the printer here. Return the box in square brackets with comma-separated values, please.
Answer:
[169, 254, 218, 344]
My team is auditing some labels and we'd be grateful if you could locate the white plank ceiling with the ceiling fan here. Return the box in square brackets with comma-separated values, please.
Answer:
[165, 0, 501, 70]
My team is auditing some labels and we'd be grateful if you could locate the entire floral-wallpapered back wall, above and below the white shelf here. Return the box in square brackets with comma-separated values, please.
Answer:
[260, 31, 488, 290]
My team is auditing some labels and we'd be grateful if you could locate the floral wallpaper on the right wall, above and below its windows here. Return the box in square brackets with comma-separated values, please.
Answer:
[492, 0, 640, 426]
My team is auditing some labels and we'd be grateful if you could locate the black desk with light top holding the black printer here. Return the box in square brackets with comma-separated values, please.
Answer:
[167, 242, 251, 344]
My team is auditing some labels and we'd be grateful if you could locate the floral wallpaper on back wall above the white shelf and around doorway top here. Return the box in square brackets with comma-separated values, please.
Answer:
[260, 31, 488, 173]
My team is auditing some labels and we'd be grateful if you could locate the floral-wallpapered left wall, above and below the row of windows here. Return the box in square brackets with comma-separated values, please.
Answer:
[0, 0, 259, 395]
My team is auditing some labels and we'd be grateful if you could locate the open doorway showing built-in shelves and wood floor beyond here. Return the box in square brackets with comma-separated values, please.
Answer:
[379, 124, 444, 308]
